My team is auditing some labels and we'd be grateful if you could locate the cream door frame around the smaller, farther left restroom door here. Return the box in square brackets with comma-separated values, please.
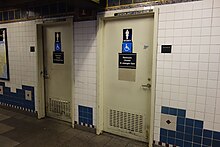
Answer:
[36, 17, 75, 127]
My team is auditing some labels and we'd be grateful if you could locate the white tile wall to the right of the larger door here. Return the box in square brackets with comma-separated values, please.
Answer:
[154, 0, 220, 141]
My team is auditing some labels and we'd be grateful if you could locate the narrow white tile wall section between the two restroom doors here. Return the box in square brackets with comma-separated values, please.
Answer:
[73, 21, 97, 124]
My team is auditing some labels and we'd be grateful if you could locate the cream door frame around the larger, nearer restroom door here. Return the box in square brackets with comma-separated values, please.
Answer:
[96, 7, 158, 147]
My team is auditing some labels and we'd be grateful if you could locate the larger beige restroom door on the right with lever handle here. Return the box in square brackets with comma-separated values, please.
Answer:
[103, 17, 153, 141]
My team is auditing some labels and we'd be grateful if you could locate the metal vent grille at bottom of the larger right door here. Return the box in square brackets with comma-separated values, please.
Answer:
[109, 109, 144, 134]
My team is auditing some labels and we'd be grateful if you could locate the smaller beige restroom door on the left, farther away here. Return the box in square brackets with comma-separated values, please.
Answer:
[43, 23, 73, 122]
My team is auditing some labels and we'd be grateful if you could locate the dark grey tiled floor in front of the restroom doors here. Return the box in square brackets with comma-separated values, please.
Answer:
[0, 107, 147, 147]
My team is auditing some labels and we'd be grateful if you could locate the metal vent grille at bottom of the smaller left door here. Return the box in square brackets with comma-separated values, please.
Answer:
[48, 98, 70, 117]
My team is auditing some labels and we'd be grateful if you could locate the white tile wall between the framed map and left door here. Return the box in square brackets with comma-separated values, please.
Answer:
[0, 21, 37, 110]
